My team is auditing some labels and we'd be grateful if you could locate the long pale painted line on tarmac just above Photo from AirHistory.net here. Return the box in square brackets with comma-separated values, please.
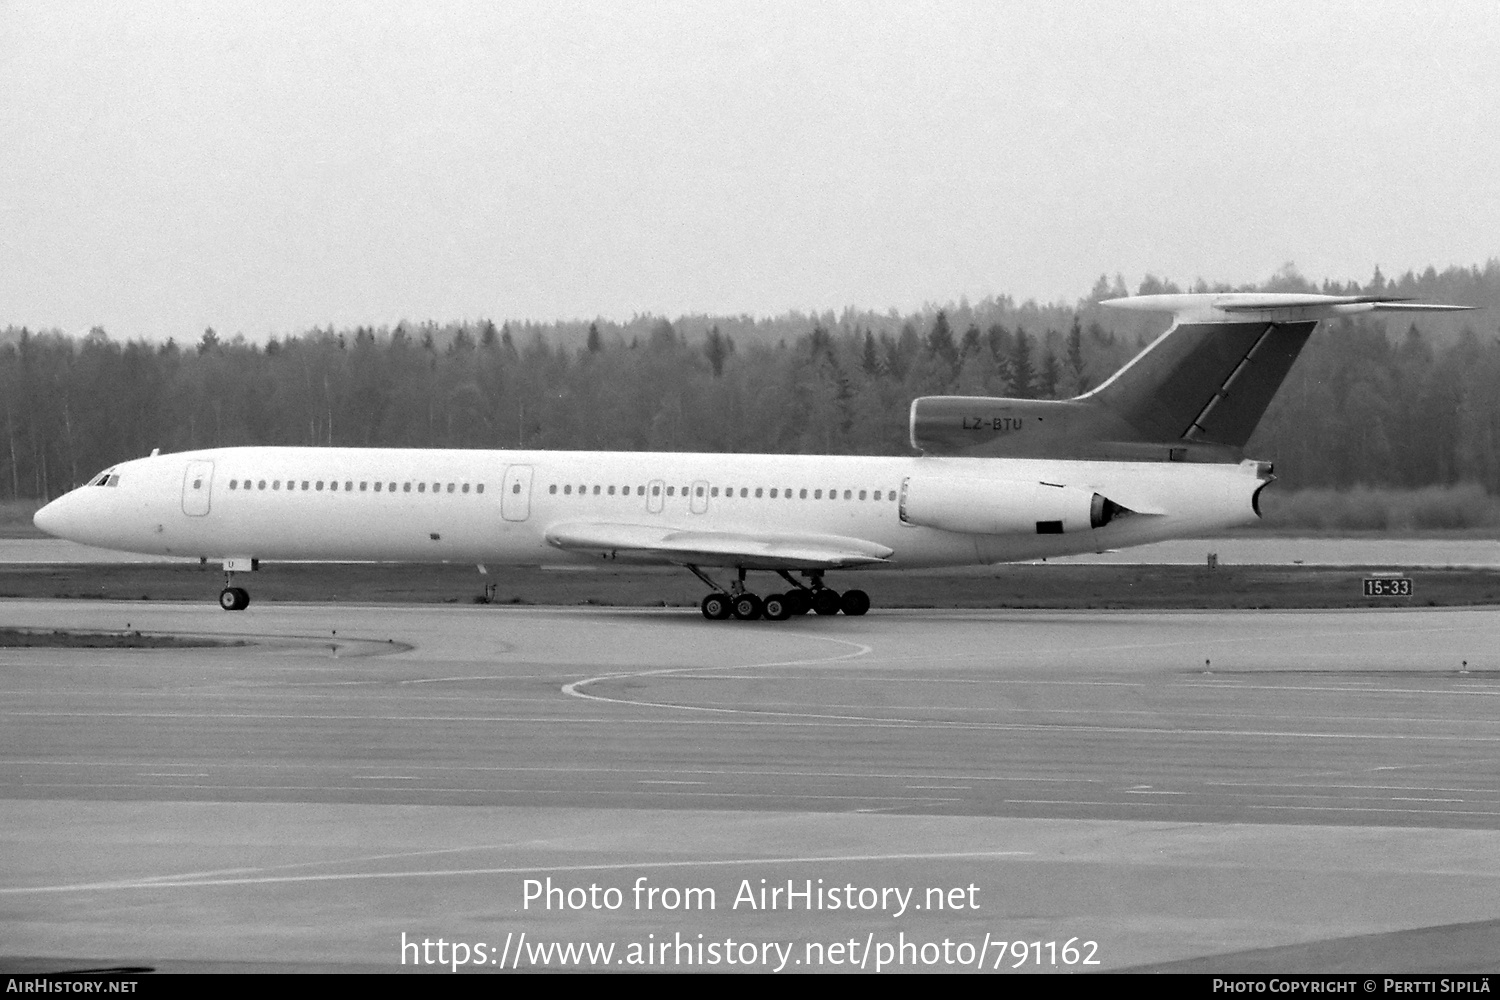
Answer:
[0, 849, 1035, 895]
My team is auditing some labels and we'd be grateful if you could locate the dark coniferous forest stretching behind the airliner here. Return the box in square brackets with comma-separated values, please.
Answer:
[0, 261, 1500, 501]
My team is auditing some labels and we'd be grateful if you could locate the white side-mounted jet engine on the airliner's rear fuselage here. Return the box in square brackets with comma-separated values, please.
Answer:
[900, 477, 1130, 535]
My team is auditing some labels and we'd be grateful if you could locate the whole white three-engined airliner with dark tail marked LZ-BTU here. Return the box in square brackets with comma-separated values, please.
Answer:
[35, 292, 1461, 621]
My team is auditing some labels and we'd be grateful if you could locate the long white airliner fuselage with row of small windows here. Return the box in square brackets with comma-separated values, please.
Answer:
[36, 447, 1265, 568]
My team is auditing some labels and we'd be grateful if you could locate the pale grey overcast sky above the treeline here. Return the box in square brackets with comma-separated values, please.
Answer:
[0, 0, 1500, 339]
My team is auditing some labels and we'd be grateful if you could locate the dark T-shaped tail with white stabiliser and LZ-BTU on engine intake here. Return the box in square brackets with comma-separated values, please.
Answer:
[911, 292, 1470, 462]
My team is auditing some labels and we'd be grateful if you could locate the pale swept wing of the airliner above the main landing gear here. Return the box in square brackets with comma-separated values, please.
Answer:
[546, 523, 894, 570]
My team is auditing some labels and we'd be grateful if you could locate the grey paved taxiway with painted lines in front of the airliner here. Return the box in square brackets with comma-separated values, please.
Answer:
[0, 601, 1500, 972]
